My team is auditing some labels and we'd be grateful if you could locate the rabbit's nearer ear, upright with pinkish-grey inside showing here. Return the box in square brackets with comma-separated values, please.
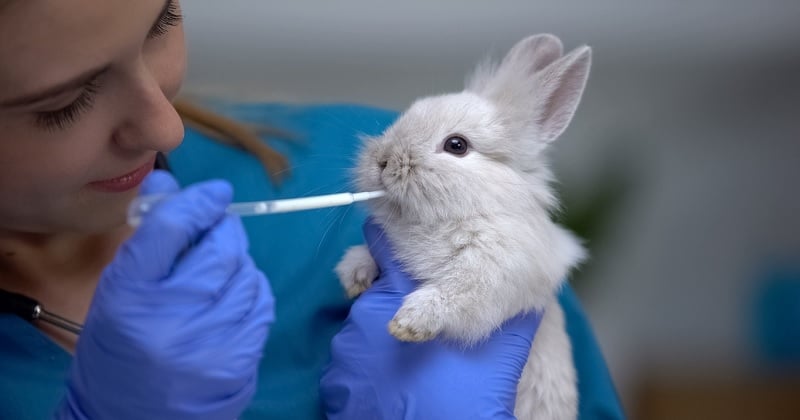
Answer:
[533, 46, 592, 142]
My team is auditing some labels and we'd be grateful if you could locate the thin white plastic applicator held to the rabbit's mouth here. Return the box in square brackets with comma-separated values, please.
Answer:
[128, 191, 385, 226]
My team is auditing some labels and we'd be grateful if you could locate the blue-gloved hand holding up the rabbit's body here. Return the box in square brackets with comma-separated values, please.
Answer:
[320, 222, 541, 419]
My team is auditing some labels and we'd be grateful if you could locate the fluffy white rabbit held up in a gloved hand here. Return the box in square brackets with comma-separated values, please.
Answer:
[336, 34, 591, 419]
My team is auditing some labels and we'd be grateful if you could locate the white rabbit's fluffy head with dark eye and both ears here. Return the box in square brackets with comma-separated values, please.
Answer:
[356, 34, 591, 225]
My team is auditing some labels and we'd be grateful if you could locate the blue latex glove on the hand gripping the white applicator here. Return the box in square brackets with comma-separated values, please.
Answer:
[57, 171, 273, 420]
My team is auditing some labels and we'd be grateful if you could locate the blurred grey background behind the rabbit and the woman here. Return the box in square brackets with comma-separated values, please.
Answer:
[183, 0, 800, 419]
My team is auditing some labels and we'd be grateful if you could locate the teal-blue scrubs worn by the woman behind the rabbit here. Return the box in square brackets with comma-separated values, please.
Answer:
[0, 104, 623, 420]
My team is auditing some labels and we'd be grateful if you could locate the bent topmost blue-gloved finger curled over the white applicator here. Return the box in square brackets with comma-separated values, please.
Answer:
[119, 181, 233, 281]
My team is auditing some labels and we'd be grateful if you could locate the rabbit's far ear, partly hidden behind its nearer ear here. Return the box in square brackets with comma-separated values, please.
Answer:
[467, 34, 563, 94]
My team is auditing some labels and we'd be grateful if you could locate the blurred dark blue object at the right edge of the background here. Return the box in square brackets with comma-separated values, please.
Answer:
[754, 264, 800, 368]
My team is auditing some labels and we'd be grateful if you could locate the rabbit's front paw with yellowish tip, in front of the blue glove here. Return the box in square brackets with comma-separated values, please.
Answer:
[389, 289, 444, 342]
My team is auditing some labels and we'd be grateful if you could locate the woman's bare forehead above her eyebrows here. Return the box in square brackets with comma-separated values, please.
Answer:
[0, 0, 164, 101]
